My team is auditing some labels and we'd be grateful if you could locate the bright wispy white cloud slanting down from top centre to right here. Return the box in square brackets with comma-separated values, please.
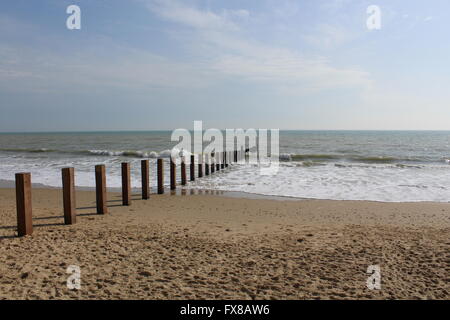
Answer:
[147, 0, 369, 93]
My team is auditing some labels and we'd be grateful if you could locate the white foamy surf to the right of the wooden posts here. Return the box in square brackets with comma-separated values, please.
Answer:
[190, 164, 450, 202]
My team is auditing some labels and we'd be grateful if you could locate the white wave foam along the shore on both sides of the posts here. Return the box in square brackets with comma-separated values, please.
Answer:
[0, 150, 450, 202]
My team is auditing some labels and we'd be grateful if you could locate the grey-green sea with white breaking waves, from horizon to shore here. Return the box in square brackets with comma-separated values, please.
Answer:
[0, 131, 450, 202]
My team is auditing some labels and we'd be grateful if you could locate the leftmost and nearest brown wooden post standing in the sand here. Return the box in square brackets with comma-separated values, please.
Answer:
[16, 173, 33, 237]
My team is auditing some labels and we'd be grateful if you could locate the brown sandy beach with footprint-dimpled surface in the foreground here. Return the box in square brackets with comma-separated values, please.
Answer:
[0, 188, 450, 299]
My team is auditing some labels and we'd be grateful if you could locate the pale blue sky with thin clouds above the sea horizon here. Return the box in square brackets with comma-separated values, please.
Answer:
[0, 0, 450, 132]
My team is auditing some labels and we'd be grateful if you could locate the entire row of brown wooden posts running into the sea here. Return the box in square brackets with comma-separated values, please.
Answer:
[15, 150, 245, 237]
